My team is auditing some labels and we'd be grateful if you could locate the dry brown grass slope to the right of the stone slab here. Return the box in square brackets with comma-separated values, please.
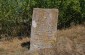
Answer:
[57, 25, 85, 55]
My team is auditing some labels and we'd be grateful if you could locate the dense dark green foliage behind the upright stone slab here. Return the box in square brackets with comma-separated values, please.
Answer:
[0, 0, 85, 36]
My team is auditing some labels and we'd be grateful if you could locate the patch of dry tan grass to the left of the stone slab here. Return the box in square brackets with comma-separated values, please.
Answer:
[0, 38, 29, 55]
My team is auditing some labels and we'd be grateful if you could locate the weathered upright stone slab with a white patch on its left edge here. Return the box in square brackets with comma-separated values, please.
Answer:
[30, 8, 58, 55]
